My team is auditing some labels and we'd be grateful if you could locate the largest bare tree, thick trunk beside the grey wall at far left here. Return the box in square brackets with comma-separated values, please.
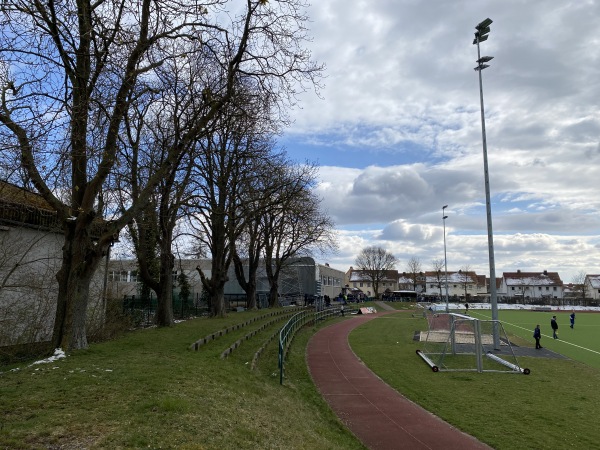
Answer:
[0, 0, 320, 349]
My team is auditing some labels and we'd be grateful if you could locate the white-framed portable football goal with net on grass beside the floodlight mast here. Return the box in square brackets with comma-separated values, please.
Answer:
[417, 313, 529, 374]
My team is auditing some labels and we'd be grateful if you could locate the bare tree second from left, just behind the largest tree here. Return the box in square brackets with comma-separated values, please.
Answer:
[115, 61, 203, 326]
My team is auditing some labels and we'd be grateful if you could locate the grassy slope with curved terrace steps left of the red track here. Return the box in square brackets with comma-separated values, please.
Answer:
[0, 312, 363, 449]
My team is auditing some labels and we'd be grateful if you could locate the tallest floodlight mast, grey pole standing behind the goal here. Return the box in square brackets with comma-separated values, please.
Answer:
[473, 18, 500, 349]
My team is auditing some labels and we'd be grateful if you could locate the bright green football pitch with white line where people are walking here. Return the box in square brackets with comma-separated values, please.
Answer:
[460, 309, 600, 369]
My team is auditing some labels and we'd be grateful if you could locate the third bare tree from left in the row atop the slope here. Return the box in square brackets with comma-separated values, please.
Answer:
[190, 110, 270, 316]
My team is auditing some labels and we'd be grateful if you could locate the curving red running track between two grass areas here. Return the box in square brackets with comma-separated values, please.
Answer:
[307, 313, 490, 450]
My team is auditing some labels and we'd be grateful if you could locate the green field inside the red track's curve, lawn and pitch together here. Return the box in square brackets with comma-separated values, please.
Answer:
[350, 311, 600, 449]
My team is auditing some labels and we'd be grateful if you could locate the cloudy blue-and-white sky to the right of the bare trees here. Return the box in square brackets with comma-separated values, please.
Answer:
[279, 0, 600, 283]
